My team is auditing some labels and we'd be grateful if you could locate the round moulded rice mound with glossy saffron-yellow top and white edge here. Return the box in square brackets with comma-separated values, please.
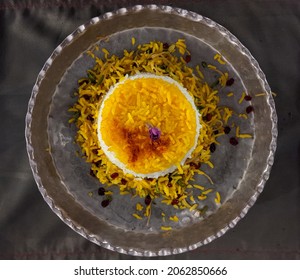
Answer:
[98, 73, 201, 178]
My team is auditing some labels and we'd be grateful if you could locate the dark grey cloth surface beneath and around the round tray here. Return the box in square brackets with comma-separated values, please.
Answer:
[0, 0, 300, 259]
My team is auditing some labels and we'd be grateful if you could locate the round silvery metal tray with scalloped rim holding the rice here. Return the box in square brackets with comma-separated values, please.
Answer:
[25, 5, 277, 256]
